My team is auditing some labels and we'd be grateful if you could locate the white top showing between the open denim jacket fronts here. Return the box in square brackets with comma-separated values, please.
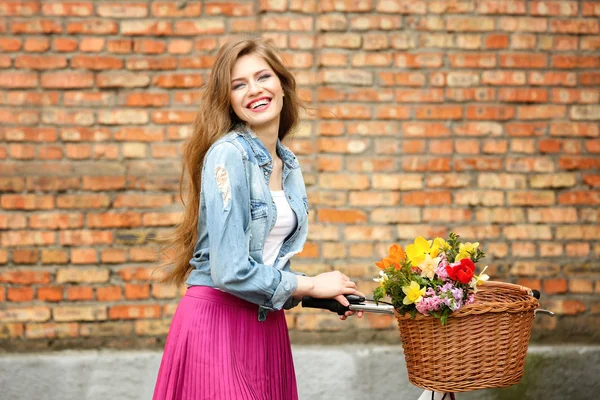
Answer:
[263, 190, 298, 265]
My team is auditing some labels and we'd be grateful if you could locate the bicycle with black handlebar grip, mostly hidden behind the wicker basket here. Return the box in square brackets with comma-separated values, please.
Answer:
[302, 290, 554, 400]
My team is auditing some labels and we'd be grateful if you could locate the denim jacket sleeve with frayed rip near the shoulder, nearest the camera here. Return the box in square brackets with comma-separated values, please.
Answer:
[202, 142, 298, 310]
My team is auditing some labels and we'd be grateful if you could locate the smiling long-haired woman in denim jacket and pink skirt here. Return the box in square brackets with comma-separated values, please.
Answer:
[154, 39, 362, 400]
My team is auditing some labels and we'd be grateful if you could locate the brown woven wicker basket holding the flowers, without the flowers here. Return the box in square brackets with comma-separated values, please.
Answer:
[395, 282, 539, 392]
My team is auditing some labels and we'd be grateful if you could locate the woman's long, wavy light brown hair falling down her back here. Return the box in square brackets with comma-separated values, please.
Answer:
[161, 38, 302, 285]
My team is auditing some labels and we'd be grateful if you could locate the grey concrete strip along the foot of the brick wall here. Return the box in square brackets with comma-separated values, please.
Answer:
[0, 346, 600, 400]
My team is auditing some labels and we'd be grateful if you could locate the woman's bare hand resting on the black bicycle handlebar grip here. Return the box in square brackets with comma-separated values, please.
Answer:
[295, 271, 364, 320]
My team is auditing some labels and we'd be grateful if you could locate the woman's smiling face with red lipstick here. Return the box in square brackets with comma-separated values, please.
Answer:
[230, 54, 284, 133]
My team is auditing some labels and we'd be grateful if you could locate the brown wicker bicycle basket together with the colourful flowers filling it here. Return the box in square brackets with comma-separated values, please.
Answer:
[373, 233, 539, 392]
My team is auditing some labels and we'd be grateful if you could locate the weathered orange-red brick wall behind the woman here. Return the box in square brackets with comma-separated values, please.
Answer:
[0, 0, 600, 350]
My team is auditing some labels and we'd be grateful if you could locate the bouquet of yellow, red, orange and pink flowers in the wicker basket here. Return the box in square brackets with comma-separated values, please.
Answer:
[373, 233, 489, 325]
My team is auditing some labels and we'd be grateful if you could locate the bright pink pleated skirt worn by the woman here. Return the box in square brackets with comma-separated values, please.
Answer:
[152, 286, 298, 400]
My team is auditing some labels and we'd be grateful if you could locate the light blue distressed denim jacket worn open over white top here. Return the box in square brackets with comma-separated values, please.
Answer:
[187, 126, 308, 321]
